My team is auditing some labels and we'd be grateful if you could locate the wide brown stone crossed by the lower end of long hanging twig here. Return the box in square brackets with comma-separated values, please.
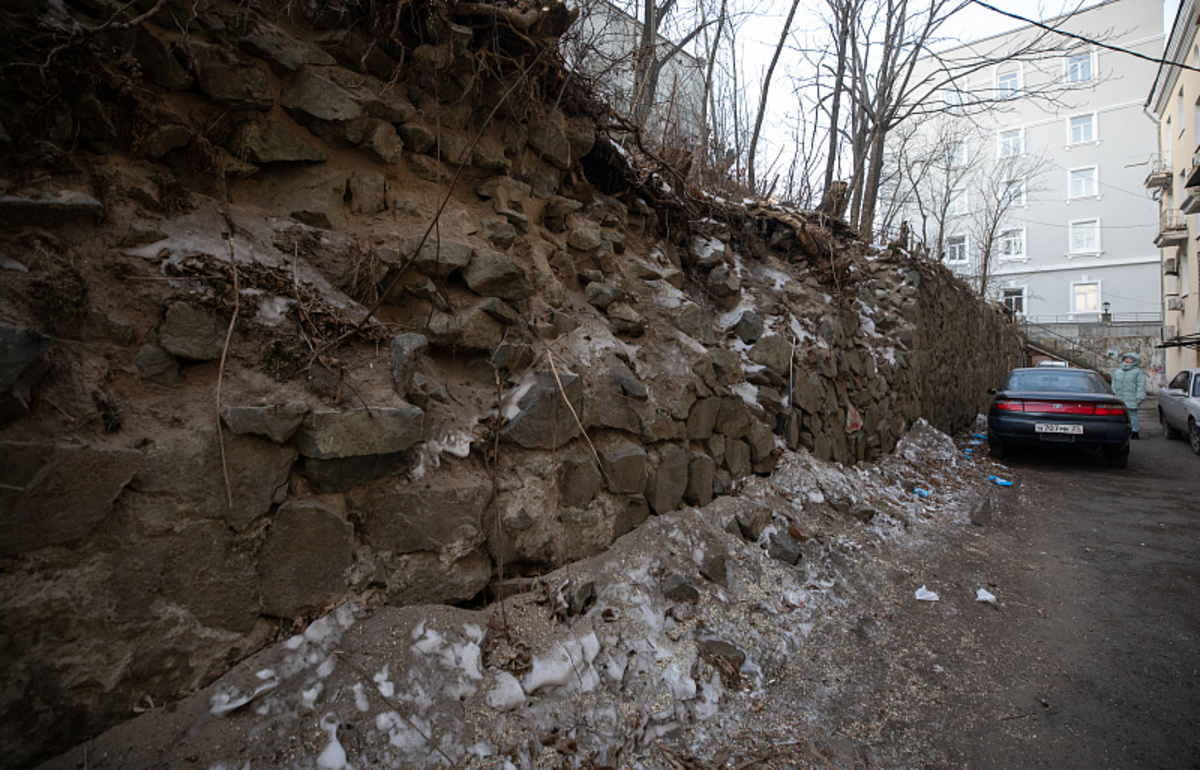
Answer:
[131, 428, 296, 531]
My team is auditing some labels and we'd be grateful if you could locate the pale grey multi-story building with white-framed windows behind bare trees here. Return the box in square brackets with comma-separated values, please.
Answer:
[904, 0, 1163, 324]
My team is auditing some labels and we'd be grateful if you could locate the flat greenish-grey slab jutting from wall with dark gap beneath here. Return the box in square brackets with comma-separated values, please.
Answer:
[295, 404, 425, 459]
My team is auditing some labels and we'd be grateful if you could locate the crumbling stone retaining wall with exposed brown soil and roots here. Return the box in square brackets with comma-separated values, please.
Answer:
[0, 0, 1018, 764]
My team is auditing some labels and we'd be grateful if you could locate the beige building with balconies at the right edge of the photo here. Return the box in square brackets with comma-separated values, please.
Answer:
[1146, 0, 1200, 377]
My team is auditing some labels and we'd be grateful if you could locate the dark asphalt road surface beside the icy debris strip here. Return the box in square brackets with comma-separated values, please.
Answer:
[806, 401, 1200, 770]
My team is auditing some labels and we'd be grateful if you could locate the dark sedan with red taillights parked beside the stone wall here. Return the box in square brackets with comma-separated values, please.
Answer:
[988, 367, 1130, 468]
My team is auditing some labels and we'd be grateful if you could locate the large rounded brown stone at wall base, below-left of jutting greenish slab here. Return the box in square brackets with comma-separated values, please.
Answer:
[258, 500, 354, 618]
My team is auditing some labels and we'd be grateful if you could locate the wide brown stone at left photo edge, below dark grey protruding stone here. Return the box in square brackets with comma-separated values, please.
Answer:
[0, 443, 143, 557]
